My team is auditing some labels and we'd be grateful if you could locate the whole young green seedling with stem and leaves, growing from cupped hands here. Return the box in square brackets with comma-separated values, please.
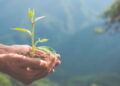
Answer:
[13, 9, 56, 57]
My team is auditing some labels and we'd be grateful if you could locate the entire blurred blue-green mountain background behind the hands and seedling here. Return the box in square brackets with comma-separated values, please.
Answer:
[0, 0, 120, 86]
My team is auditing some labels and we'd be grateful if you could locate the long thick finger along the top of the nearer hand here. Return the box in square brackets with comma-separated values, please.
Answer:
[6, 54, 47, 69]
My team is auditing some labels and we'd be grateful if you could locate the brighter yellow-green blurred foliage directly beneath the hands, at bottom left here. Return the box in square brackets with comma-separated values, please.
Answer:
[0, 73, 59, 86]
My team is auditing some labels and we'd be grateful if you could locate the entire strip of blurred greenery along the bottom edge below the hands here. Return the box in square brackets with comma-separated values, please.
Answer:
[0, 73, 120, 86]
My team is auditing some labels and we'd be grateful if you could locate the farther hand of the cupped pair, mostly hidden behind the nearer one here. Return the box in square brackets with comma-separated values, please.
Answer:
[0, 44, 60, 68]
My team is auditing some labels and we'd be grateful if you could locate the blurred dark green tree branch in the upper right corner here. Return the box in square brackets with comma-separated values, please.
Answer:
[103, 0, 120, 32]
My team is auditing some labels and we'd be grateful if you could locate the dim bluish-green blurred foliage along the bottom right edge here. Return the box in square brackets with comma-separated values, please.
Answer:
[59, 74, 120, 86]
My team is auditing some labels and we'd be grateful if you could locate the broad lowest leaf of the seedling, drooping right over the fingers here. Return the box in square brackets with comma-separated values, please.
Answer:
[37, 46, 56, 58]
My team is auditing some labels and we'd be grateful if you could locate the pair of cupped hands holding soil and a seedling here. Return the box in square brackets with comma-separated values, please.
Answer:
[0, 45, 60, 84]
